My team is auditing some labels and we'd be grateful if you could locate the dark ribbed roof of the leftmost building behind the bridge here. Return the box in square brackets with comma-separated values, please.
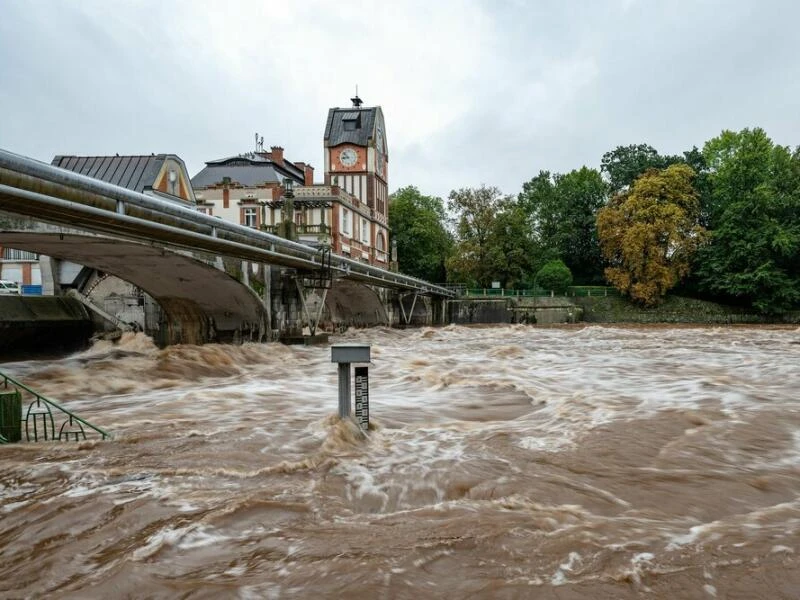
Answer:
[51, 154, 177, 193]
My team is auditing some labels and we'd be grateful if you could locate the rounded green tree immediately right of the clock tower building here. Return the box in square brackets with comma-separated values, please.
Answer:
[389, 186, 453, 282]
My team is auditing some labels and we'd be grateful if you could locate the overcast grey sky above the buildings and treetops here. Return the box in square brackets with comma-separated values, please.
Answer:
[0, 0, 800, 197]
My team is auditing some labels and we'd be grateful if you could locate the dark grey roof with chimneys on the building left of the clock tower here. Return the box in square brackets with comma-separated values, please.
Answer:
[192, 153, 305, 189]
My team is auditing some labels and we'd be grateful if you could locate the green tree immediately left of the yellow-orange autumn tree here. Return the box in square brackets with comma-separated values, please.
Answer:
[519, 167, 607, 283]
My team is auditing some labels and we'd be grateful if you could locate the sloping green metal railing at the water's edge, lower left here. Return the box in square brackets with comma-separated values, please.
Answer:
[0, 372, 111, 443]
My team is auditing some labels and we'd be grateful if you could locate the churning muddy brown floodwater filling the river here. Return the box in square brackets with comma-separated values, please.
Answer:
[0, 326, 800, 600]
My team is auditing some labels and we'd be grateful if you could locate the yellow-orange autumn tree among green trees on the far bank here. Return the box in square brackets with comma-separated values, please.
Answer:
[597, 164, 706, 306]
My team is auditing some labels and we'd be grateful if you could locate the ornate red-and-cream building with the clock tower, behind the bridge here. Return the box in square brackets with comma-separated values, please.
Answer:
[192, 97, 389, 266]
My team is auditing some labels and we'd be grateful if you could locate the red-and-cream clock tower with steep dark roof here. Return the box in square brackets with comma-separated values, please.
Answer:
[324, 96, 389, 220]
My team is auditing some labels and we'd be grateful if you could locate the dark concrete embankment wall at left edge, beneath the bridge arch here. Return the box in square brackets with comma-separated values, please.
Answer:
[0, 296, 94, 360]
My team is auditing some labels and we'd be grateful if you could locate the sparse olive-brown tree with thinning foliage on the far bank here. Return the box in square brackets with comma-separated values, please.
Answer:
[447, 185, 524, 287]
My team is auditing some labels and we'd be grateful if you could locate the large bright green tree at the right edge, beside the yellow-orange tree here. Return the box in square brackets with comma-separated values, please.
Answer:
[698, 128, 800, 314]
